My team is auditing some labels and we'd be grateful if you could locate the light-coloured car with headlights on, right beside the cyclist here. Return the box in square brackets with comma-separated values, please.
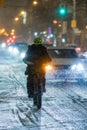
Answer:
[47, 47, 86, 82]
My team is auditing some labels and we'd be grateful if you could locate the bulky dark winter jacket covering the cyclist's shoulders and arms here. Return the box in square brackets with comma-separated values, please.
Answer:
[23, 44, 51, 65]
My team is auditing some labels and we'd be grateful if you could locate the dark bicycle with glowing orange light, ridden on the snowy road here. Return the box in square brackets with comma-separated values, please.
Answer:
[25, 62, 51, 109]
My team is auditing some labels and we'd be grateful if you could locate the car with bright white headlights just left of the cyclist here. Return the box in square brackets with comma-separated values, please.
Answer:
[7, 42, 28, 59]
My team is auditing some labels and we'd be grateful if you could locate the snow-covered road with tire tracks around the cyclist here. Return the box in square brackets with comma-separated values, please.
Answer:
[0, 63, 87, 130]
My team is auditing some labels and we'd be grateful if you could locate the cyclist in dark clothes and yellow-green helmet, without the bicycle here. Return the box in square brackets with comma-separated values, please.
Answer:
[23, 37, 51, 98]
